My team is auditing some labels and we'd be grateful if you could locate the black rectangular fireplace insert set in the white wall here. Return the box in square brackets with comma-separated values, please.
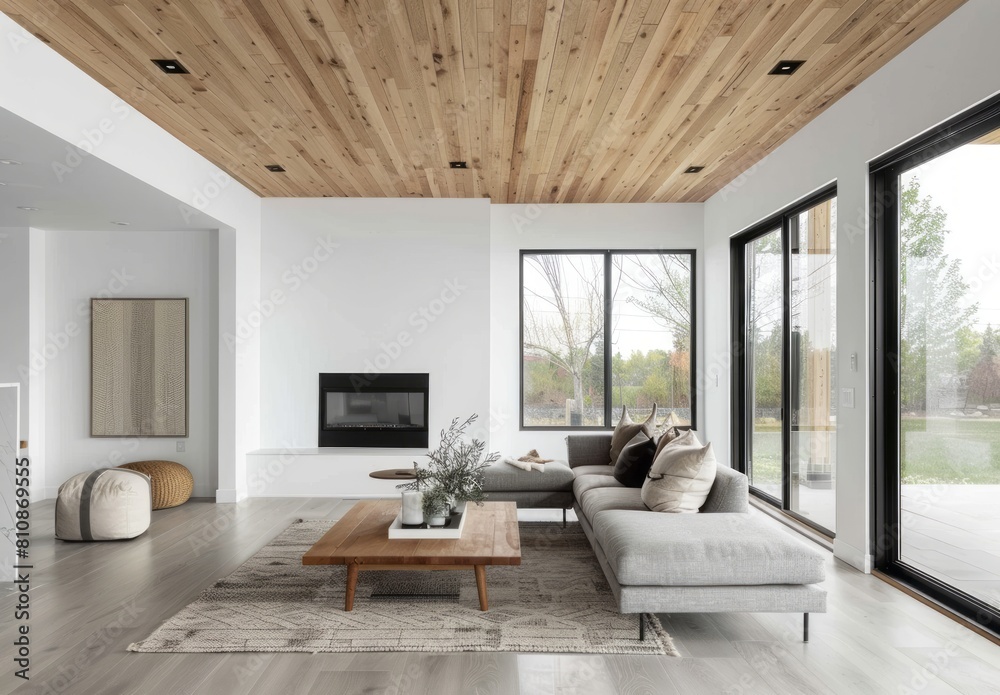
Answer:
[318, 373, 430, 449]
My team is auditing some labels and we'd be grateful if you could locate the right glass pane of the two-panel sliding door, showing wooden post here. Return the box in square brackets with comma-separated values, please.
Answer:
[788, 198, 837, 531]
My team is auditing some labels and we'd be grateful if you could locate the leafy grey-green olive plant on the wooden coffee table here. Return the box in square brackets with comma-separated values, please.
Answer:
[399, 413, 500, 512]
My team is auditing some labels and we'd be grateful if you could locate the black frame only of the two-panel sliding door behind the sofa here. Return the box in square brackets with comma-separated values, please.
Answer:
[730, 182, 837, 538]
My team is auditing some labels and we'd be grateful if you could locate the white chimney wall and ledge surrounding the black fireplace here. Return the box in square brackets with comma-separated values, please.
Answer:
[248, 199, 490, 496]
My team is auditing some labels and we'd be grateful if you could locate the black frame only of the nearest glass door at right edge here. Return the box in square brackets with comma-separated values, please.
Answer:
[869, 89, 1000, 634]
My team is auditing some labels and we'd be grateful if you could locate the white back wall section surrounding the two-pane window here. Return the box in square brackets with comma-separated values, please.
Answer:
[490, 203, 704, 460]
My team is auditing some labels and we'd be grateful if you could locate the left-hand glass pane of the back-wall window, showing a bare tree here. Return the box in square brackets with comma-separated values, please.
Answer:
[522, 254, 606, 427]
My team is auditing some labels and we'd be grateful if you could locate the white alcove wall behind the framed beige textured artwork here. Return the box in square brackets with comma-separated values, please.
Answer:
[44, 231, 218, 497]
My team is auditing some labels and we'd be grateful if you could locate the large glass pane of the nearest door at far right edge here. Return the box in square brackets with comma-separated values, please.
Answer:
[899, 131, 1000, 607]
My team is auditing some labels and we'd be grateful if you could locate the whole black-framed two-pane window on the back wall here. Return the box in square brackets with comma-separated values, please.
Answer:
[520, 250, 696, 430]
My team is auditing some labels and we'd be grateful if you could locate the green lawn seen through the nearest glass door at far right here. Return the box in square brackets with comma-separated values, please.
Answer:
[900, 417, 1000, 485]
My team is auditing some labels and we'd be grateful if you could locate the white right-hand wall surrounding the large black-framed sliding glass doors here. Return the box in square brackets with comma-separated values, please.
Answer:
[705, 0, 1000, 569]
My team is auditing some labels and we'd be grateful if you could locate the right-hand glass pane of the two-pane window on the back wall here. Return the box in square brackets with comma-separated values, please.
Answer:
[611, 253, 691, 425]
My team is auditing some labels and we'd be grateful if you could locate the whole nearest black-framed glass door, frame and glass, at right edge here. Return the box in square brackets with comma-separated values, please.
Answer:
[871, 89, 1000, 634]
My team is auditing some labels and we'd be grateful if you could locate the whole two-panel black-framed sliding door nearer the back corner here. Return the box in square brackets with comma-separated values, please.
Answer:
[731, 186, 838, 536]
